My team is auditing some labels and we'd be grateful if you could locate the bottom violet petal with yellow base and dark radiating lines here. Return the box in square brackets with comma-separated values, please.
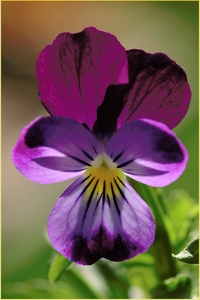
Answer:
[48, 174, 155, 265]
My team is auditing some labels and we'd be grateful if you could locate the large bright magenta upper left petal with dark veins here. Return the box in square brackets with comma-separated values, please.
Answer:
[36, 27, 128, 129]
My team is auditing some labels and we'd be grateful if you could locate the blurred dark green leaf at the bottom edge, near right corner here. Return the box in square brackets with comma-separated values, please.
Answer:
[150, 275, 192, 299]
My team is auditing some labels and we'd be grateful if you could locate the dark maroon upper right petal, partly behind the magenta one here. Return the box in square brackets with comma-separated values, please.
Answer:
[94, 49, 191, 137]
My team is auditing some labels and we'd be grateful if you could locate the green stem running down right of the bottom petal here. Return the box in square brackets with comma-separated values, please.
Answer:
[139, 184, 177, 281]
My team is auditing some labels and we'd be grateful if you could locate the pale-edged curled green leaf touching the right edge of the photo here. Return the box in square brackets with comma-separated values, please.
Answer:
[172, 236, 199, 264]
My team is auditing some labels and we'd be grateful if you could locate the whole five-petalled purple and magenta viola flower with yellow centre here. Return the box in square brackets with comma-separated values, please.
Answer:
[13, 27, 191, 265]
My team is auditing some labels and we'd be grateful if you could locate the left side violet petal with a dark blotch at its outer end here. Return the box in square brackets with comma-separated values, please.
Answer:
[13, 117, 102, 183]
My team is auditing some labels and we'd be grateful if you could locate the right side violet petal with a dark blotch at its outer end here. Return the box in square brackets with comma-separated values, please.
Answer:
[105, 119, 188, 187]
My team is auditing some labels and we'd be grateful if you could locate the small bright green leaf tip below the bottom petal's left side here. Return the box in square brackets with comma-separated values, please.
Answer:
[48, 253, 72, 282]
